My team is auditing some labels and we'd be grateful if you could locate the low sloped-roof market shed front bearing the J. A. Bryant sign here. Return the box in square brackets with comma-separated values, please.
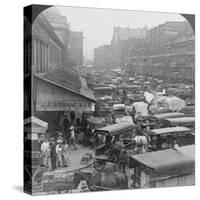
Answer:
[33, 68, 95, 134]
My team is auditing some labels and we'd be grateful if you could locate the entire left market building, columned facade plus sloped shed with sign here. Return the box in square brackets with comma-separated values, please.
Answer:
[31, 9, 95, 135]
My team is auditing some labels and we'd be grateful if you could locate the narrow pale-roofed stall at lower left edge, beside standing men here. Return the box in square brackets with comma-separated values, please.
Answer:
[24, 116, 48, 192]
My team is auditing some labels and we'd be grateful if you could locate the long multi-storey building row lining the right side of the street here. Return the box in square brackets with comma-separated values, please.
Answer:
[128, 21, 195, 81]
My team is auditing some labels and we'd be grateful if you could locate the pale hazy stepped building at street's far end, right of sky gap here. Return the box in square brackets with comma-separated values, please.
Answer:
[94, 26, 148, 69]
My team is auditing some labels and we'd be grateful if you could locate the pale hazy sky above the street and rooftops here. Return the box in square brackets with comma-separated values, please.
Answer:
[57, 7, 184, 59]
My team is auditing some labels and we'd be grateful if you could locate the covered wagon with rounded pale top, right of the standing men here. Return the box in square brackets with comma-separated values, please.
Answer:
[94, 122, 135, 171]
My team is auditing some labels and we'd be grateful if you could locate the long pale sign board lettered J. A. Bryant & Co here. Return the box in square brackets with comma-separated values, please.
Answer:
[36, 101, 94, 112]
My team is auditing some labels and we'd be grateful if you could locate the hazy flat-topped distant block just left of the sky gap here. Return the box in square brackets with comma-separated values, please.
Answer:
[69, 31, 84, 66]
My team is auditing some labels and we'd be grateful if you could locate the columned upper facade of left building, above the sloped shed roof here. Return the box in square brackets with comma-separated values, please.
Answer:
[31, 13, 65, 73]
